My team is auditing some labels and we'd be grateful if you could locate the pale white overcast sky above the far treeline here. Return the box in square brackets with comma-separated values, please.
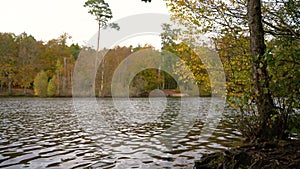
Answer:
[0, 0, 168, 46]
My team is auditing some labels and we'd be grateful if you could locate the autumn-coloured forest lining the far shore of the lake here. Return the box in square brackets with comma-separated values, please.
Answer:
[0, 28, 216, 97]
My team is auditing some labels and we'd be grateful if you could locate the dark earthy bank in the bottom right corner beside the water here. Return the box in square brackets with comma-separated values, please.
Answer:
[194, 140, 300, 169]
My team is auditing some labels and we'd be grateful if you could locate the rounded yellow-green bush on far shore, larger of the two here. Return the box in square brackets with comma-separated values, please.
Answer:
[34, 70, 48, 97]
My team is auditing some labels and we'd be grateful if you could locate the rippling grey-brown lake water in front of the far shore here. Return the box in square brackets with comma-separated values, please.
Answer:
[0, 98, 242, 169]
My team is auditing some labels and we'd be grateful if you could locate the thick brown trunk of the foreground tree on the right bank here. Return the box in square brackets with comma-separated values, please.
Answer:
[248, 0, 280, 140]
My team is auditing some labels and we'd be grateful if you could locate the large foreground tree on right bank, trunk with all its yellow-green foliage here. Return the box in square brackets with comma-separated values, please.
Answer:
[155, 0, 300, 139]
